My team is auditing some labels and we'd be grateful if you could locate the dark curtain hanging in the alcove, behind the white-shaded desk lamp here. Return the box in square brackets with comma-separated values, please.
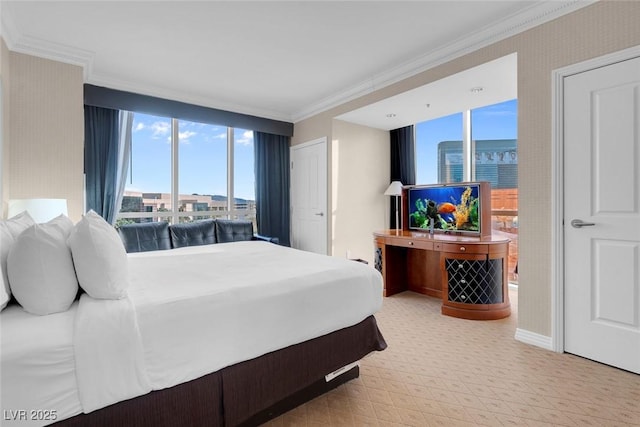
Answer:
[389, 125, 416, 228]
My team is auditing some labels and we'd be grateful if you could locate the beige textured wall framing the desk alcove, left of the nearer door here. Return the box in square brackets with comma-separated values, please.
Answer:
[292, 1, 640, 337]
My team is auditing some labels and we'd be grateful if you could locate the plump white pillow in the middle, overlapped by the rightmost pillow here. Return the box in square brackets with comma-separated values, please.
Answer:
[7, 216, 78, 316]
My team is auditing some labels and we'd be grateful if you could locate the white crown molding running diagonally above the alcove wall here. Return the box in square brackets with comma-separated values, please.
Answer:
[291, 0, 598, 123]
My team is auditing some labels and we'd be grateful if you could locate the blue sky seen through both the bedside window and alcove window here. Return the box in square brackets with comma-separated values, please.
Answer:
[126, 100, 517, 200]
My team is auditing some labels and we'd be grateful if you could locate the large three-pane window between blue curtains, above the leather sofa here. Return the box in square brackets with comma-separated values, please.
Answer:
[118, 113, 255, 227]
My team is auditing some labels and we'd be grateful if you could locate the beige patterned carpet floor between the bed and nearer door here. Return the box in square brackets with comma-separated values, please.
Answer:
[266, 290, 640, 427]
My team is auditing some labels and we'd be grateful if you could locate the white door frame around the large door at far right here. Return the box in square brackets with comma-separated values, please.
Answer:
[551, 45, 640, 353]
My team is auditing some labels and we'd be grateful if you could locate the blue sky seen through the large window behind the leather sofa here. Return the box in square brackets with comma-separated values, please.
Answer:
[126, 113, 255, 200]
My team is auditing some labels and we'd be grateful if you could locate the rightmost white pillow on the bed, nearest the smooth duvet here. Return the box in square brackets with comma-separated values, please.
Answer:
[67, 211, 129, 299]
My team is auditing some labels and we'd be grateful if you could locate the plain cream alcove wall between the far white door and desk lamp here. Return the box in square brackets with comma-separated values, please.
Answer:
[329, 120, 390, 265]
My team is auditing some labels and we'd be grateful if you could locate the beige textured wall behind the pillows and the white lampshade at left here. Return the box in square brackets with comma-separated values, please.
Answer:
[2, 52, 84, 221]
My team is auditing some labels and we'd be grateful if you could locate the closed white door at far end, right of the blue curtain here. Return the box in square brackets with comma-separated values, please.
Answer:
[291, 138, 328, 254]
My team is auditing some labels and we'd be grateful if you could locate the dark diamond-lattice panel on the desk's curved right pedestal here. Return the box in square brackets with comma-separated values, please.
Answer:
[445, 258, 503, 304]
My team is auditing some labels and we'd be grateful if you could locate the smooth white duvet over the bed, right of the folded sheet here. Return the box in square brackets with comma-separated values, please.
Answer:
[129, 241, 382, 389]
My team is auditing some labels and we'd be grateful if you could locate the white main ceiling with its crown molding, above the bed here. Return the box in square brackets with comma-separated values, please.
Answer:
[0, 0, 591, 128]
